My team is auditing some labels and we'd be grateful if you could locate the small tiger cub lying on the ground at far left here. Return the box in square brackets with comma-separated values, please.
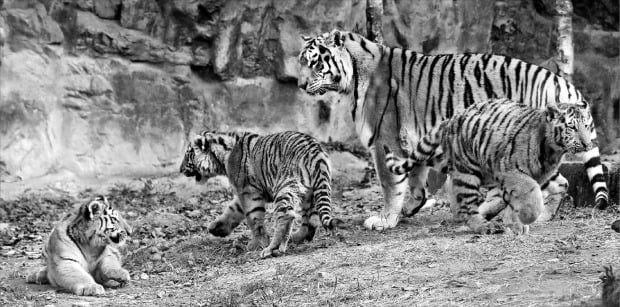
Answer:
[27, 196, 131, 295]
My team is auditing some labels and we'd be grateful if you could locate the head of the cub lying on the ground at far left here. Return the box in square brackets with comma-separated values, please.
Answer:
[69, 196, 132, 249]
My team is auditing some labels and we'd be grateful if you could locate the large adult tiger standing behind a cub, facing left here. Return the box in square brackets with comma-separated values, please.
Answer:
[298, 30, 608, 230]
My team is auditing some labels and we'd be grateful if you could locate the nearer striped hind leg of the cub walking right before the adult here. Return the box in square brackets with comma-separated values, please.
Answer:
[451, 171, 504, 234]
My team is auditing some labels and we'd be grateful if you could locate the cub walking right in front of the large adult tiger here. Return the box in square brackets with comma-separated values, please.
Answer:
[384, 99, 592, 233]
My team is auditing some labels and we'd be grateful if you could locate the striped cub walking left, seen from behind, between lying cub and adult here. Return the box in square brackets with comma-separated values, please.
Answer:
[181, 131, 340, 258]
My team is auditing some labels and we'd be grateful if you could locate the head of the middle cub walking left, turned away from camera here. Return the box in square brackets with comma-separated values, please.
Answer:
[180, 132, 226, 182]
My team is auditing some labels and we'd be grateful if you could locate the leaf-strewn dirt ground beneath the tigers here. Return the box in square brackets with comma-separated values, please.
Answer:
[0, 167, 620, 306]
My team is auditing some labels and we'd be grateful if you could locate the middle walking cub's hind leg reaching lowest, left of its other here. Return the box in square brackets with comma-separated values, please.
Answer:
[261, 181, 305, 258]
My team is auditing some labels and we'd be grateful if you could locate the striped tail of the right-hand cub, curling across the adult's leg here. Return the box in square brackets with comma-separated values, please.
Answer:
[383, 125, 445, 175]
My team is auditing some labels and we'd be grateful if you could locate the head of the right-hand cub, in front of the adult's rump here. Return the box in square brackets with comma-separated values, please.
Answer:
[545, 101, 594, 153]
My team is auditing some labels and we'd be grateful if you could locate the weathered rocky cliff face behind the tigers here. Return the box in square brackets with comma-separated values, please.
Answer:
[0, 0, 620, 180]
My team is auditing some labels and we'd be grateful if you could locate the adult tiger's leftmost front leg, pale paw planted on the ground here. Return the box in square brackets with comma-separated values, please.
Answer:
[364, 144, 408, 230]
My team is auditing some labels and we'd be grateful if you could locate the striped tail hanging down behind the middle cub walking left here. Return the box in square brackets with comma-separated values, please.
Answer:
[312, 159, 341, 229]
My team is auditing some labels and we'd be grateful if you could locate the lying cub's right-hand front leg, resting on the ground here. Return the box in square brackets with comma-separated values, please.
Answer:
[94, 247, 131, 287]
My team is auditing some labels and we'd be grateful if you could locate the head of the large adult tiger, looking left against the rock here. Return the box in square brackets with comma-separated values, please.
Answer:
[297, 32, 353, 95]
